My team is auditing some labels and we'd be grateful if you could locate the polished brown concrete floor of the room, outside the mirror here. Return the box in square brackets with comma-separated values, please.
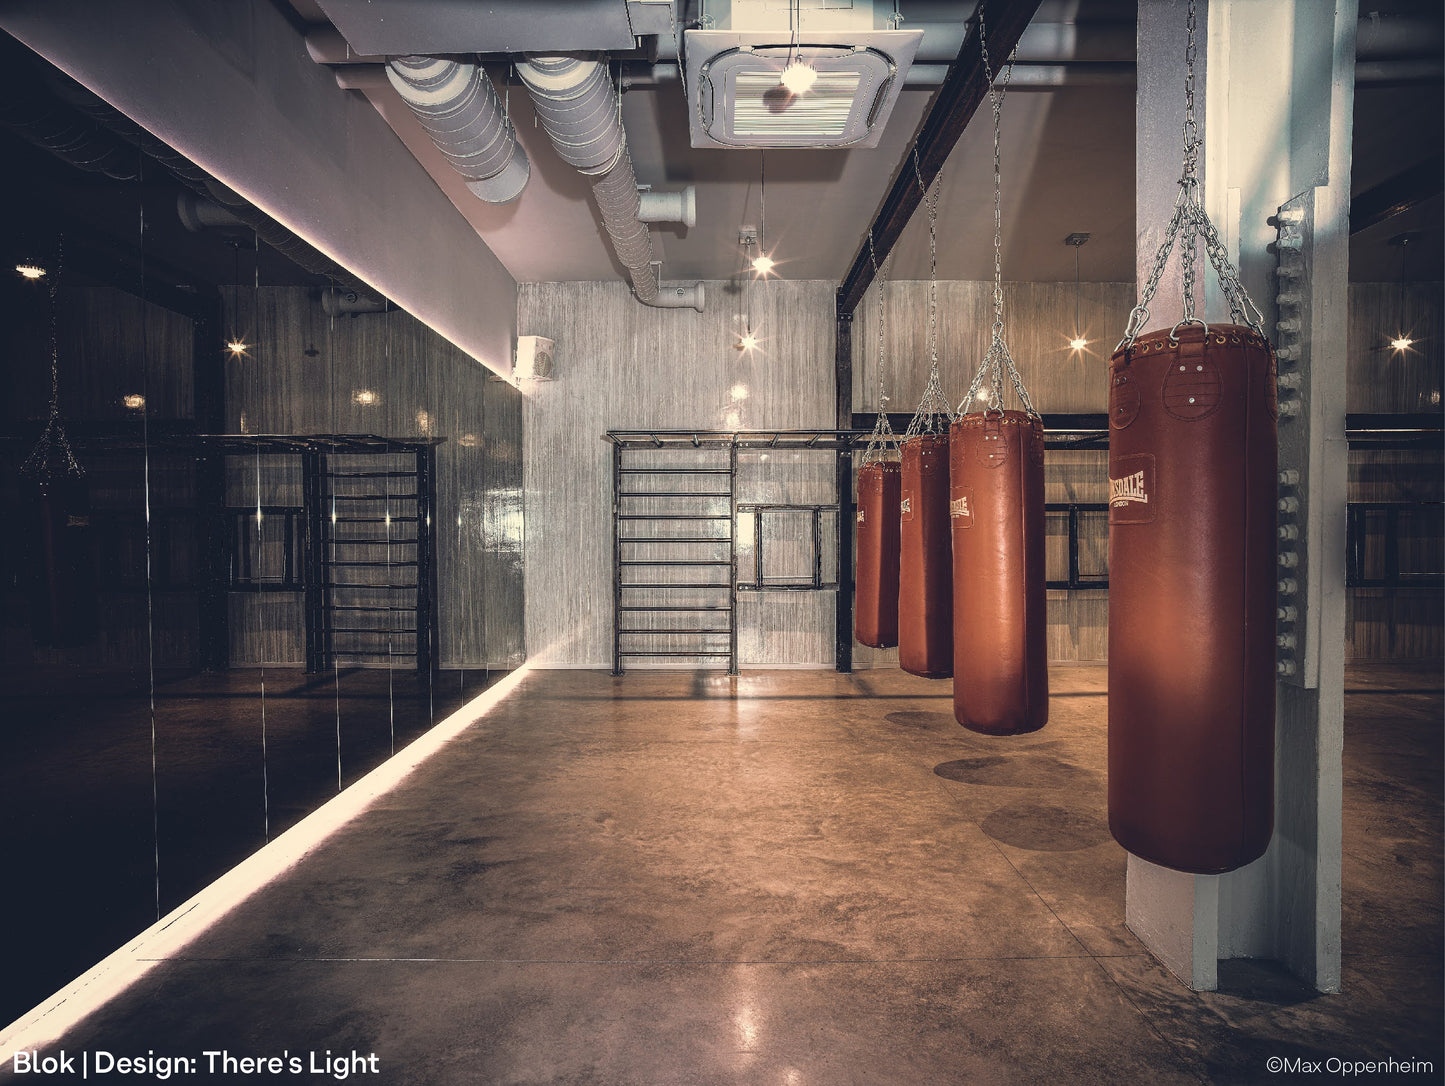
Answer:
[0, 666, 1445, 1086]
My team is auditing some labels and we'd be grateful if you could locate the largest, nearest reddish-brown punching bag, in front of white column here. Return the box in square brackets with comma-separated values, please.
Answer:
[1108, 323, 1277, 874]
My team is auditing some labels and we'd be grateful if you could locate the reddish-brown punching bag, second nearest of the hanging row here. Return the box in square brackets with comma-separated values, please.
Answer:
[948, 410, 1049, 735]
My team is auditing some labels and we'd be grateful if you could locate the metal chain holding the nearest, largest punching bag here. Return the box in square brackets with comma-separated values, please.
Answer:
[1114, 0, 1267, 351]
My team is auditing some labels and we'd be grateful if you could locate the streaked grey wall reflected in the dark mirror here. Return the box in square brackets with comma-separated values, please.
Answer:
[224, 287, 523, 667]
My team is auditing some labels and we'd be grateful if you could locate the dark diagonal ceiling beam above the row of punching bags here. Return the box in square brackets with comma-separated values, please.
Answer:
[838, 0, 1039, 318]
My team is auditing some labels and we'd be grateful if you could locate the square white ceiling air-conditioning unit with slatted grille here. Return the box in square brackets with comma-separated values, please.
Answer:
[686, 30, 923, 147]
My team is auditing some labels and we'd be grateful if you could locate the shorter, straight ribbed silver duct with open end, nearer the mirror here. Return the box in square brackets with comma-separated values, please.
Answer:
[386, 56, 532, 204]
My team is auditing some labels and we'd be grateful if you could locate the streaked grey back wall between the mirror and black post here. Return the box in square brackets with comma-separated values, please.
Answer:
[517, 280, 834, 667]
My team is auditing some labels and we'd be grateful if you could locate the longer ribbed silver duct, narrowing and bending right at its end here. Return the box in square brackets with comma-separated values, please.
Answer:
[517, 53, 705, 312]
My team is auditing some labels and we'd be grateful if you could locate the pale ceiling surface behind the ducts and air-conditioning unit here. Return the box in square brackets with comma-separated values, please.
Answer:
[290, 0, 1441, 282]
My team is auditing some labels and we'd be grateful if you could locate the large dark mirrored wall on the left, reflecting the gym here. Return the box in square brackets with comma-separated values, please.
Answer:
[0, 39, 522, 1021]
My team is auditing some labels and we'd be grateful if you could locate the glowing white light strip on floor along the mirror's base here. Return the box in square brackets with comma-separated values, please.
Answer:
[0, 664, 527, 1067]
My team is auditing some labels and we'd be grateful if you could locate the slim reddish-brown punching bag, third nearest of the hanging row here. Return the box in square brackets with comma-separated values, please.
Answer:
[899, 433, 954, 679]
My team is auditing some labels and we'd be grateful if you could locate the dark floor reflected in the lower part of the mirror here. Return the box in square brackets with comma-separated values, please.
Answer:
[0, 667, 503, 1024]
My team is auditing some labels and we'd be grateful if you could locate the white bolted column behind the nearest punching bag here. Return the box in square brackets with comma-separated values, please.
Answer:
[1126, 0, 1358, 991]
